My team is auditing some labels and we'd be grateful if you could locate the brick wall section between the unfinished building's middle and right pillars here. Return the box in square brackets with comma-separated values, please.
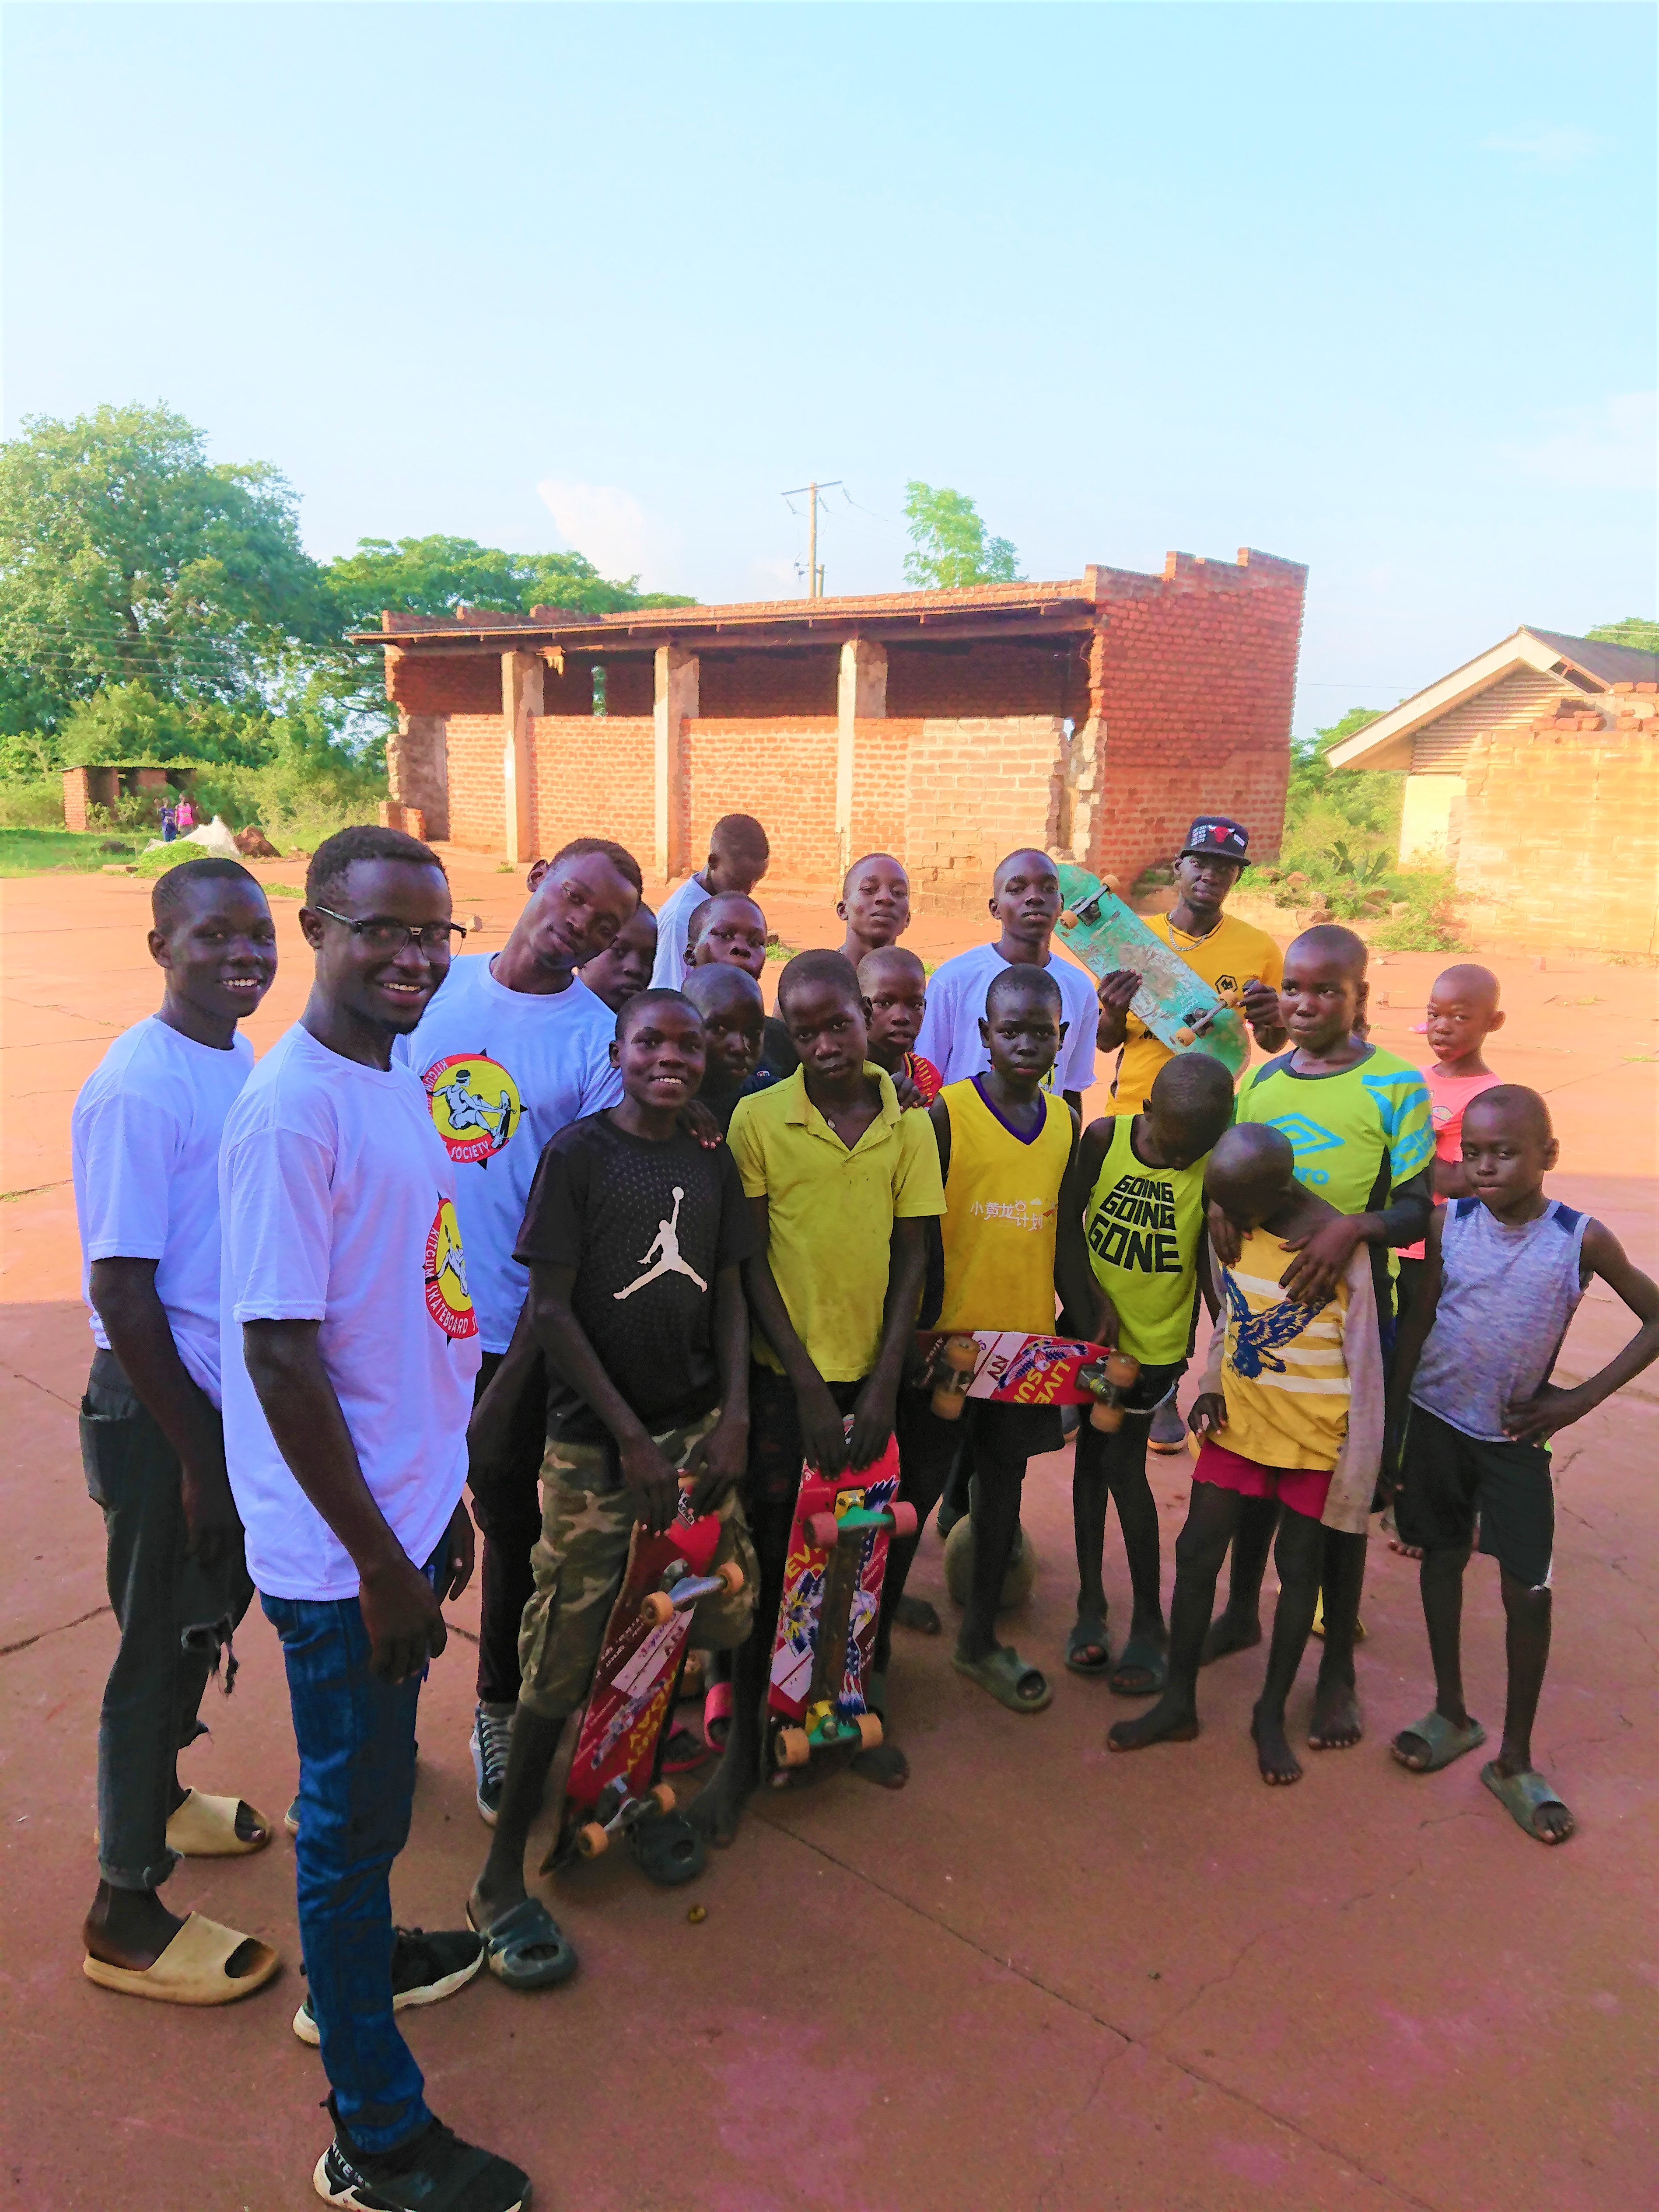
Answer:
[679, 712, 836, 882]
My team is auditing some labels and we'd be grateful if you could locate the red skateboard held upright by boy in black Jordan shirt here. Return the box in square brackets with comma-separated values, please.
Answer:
[553, 1484, 743, 1862]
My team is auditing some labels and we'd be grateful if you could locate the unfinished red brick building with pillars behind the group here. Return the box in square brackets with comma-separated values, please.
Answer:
[365, 551, 1307, 911]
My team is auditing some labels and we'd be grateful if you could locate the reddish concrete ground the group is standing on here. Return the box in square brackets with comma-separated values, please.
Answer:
[0, 856, 1659, 2212]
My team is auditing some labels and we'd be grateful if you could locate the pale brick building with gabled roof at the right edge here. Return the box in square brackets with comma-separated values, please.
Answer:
[1332, 626, 1659, 953]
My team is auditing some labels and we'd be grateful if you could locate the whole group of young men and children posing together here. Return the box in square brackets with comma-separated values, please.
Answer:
[73, 816, 1659, 2212]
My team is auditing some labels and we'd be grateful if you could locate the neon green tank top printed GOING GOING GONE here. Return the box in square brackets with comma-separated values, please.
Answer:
[1084, 1113, 1208, 1367]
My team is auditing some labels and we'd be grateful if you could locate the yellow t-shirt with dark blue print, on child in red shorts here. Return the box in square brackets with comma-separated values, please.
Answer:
[1217, 1230, 1349, 1469]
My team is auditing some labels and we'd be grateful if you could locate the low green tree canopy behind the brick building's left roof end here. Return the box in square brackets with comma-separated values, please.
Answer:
[325, 538, 695, 630]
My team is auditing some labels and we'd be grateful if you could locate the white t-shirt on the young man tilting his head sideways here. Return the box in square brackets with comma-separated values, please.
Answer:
[392, 953, 622, 1351]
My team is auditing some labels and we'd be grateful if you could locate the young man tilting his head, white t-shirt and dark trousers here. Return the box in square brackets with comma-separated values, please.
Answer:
[394, 836, 639, 1827]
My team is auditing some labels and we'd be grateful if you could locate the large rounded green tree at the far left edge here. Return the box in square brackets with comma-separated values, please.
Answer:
[0, 407, 339, 728]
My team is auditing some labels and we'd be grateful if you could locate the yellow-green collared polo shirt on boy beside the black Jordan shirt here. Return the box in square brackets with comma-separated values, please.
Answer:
[728, 1060, 945, 1382]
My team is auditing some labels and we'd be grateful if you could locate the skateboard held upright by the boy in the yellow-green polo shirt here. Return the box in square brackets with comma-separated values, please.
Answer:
[765, 1435, 916, 1778]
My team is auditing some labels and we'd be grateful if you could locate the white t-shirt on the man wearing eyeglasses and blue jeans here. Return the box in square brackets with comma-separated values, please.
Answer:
[219, 1024, 478, 1599]
